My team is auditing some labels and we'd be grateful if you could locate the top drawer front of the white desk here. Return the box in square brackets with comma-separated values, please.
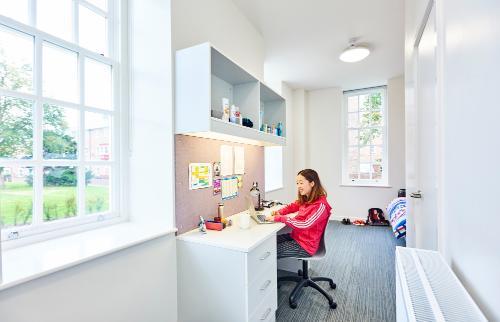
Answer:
[247, 236, 276, 284]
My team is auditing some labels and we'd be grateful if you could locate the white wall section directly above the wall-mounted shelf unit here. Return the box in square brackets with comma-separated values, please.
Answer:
[172, 0, 264, 79]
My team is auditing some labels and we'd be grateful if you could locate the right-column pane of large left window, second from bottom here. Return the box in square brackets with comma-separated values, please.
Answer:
[85, 112, 111, 160]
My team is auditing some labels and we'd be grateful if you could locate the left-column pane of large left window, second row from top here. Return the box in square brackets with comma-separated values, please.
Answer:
[0, 27, 33, 93]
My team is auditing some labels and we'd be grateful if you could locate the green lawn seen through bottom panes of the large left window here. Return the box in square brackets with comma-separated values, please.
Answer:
[0, 182, 109, 226]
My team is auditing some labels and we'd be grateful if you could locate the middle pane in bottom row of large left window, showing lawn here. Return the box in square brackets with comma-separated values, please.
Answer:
[43, 167, 78, 221]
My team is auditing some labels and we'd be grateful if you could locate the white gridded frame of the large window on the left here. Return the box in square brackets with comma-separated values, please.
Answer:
[0, 0, 128, 244]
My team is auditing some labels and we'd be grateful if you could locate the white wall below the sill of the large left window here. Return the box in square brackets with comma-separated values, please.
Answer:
[0, 235, 177, 322]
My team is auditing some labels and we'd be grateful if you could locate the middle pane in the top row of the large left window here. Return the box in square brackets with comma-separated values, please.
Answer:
[36, 0, 73, 41]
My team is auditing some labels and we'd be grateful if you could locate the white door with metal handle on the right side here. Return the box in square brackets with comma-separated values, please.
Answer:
[406, 1, 438, 250]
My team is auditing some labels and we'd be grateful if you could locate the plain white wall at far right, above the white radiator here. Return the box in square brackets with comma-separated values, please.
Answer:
[437, 0, 500, 321]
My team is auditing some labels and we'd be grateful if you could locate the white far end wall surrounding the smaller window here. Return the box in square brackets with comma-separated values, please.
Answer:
[302, 77, 405, 219]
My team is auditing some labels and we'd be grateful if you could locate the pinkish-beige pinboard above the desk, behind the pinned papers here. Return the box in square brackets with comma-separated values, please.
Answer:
[175, 134, 264, 234]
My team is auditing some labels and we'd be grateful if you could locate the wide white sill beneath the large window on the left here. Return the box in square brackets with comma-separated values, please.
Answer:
[0, 222, 177, 291]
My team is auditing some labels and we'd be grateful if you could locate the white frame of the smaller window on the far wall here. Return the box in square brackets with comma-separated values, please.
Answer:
[340, 85, 389, 187]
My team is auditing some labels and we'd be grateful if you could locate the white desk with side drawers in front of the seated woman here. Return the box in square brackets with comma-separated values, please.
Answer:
[177, 209, 284, 322]
